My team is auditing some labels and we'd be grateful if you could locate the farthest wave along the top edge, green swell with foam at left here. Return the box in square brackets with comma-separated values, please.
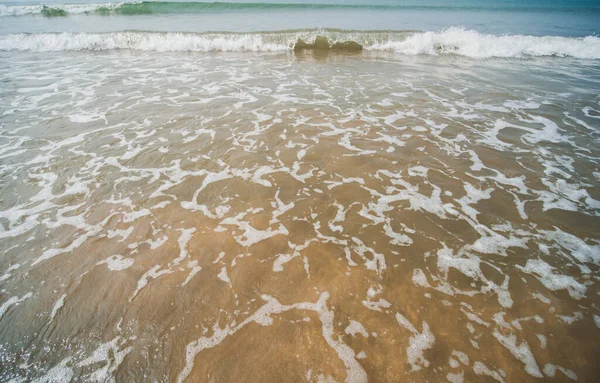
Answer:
[0, 0, 600, 17]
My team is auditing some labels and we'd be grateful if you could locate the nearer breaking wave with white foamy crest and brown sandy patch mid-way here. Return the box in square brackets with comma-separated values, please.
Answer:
[0, 27, 600, 59]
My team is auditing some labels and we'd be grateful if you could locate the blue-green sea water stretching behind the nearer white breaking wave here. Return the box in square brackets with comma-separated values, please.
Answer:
[0, 0, 600, 37]
